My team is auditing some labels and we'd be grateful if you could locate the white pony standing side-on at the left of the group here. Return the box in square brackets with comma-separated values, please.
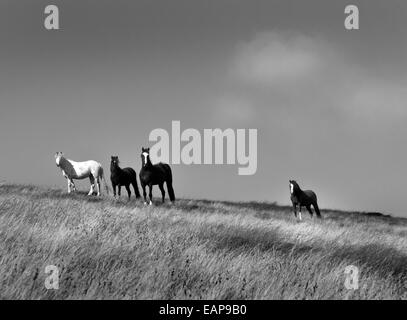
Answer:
[55, 152, 109, 196]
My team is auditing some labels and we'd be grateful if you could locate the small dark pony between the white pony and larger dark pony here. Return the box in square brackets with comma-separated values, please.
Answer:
[110, 156, 140, 200]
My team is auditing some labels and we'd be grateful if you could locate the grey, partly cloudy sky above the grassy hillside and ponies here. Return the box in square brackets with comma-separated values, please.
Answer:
[0, 0, 407, 217]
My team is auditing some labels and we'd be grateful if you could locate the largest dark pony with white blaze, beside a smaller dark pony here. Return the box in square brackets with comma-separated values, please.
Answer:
[139, 148, 175, 204]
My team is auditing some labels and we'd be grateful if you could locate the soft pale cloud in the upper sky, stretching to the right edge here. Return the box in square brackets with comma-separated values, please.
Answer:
[231, 32, 407, 122]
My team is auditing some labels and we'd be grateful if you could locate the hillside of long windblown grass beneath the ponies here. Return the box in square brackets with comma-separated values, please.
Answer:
[0, 185, 407, 299]
